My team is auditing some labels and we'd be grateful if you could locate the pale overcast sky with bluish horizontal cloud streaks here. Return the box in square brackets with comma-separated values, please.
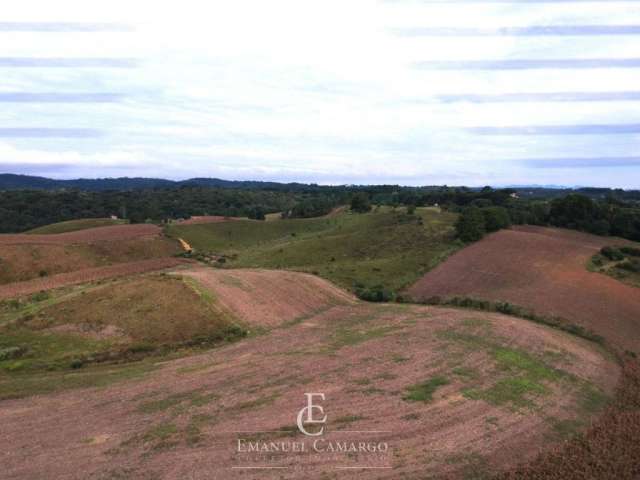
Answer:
[0, 0, 640, 188]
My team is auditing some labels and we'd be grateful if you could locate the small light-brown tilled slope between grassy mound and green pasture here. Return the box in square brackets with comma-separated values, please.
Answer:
[180, 267, 355, 327]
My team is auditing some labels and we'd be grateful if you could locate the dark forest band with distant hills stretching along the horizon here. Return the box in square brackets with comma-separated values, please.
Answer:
[0, 174, 640, 241]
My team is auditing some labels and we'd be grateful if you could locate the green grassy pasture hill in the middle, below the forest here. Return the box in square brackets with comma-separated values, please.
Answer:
[167, 208, 462, 292]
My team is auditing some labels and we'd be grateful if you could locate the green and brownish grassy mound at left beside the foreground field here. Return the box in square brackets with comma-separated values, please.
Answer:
[0, 274, 246, 398]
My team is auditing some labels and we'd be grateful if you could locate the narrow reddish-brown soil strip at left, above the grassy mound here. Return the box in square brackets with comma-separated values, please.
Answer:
[0, 258, 186, 299]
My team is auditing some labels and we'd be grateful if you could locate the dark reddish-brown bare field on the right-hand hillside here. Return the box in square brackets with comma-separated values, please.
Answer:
[409, 226, 640, 351]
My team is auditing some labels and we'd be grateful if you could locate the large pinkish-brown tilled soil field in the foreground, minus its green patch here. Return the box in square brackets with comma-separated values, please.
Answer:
[0, 304, 618, 480]
